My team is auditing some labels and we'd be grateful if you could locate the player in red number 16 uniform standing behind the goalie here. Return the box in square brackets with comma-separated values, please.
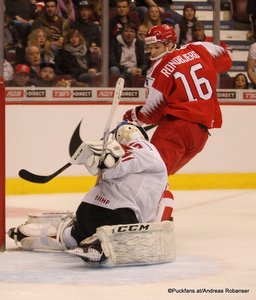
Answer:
[123, 25, 232, 175]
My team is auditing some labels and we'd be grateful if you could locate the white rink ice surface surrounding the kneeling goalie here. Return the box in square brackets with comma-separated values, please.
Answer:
[0, 190, 256, 300]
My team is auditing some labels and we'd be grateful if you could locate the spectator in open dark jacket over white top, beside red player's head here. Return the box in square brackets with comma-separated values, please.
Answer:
[109, 23, 147, 85]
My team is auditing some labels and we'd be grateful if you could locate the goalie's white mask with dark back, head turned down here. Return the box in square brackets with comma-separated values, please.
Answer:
[115, 122, 149, 145]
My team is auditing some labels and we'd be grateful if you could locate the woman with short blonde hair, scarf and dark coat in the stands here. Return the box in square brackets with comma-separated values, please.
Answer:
[55, 29, 99, 86]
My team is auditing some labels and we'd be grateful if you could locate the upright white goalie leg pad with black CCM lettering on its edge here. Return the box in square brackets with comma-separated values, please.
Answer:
[96, 221, 176, 267]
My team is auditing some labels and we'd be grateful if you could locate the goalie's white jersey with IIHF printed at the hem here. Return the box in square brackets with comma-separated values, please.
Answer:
[83, 140, 168, 223]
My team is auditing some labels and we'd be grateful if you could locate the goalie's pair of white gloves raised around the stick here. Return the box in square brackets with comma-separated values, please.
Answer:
[70, 139, 125, 175]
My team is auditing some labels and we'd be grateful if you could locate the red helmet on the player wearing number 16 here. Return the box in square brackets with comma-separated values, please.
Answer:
[145, 24, 177, 46]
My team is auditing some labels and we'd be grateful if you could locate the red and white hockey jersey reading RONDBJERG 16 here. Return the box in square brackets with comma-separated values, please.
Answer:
[138, 42, 232, 128]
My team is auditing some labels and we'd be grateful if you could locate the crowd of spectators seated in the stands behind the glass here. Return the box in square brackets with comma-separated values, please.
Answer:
[1, 0, 256, 86]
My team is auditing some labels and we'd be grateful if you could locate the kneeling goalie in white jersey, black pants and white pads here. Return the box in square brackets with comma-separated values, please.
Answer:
[8, 122, 175, 266]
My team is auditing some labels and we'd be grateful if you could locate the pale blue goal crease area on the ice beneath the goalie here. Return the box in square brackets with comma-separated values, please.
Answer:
[0, 251, 221, 285]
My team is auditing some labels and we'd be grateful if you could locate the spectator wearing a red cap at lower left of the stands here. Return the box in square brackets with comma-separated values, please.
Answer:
[6, 64, 33, 87]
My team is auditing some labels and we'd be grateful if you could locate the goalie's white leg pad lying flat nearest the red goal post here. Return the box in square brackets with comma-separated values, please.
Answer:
[8, 212, 75, 251]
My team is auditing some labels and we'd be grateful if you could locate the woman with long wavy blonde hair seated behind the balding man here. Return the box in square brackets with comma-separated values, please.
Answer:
[28, 27, 54, 62]
